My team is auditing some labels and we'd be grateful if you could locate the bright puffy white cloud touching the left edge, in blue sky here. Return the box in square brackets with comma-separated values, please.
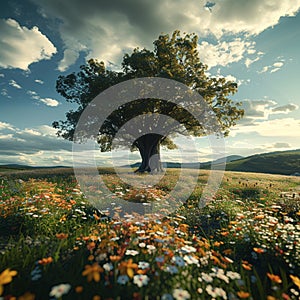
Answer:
[0, 19, 56, 70]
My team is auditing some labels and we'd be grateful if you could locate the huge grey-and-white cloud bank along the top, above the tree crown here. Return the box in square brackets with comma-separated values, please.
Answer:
[32, 0, 300, 71]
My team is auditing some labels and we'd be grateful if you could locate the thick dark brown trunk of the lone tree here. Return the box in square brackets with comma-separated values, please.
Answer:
[134, 133, 163, 173]
